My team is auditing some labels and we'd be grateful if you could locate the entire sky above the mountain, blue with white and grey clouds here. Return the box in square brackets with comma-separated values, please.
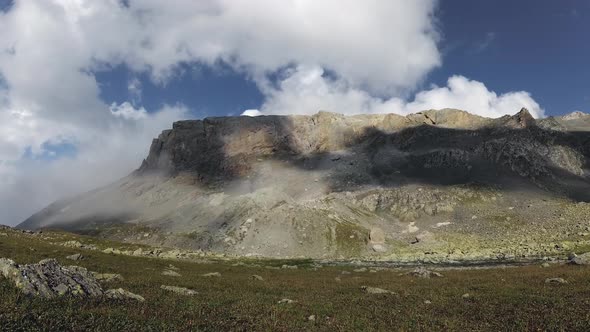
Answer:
[0, 0, 590, 225]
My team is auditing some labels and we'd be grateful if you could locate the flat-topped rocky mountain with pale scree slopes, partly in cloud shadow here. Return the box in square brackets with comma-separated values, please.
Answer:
[19, 109, 590, 261]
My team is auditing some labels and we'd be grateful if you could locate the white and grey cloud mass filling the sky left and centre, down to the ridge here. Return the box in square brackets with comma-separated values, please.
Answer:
[0, 0, 542, 223]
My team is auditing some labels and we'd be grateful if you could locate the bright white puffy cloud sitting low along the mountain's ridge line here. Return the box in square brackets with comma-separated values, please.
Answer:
[260, 66, 544, 118]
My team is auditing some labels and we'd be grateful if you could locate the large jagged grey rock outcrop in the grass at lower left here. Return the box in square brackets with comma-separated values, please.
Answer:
[0, 258, 144, 302]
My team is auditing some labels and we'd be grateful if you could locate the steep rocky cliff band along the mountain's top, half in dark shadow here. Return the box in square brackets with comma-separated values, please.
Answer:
[137, 109, 590, 189]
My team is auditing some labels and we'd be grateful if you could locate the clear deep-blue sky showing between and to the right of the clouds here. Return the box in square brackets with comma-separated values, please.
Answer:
[85, 0, 590, 118]
